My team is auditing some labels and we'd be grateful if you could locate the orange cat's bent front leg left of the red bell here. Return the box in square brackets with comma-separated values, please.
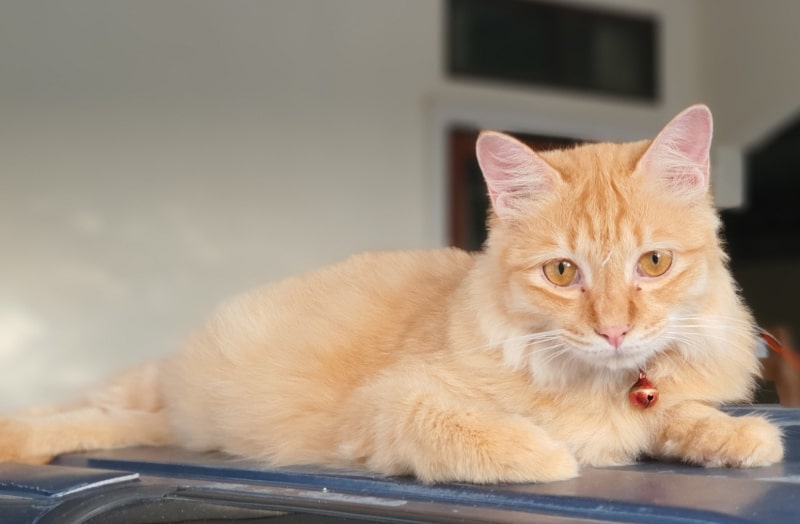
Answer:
[339, 377, 578, 483]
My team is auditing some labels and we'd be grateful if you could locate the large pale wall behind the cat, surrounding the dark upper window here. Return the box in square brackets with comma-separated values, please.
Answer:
[0, 0, 776, 409]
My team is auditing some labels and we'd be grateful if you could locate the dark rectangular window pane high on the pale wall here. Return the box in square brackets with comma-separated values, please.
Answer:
[447, 0, 658, 100]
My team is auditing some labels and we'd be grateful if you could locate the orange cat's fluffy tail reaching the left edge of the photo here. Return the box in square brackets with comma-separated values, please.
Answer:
[0, 362, 172, 463]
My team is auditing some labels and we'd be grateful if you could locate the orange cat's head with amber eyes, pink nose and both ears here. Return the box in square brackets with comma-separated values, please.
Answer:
[477, 105, 740, 376]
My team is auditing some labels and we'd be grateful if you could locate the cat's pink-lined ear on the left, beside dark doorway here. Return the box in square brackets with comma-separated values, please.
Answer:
[475, 131, 560, 218]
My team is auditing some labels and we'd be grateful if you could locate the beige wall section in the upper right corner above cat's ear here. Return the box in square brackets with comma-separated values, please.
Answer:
[697, 0, 800, 149]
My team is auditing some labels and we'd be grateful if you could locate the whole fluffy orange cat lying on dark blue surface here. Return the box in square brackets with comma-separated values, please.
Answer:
[0, 105, 783, 483]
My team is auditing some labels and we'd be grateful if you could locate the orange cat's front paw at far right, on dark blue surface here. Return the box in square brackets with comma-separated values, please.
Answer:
[665, 416, 783, 468]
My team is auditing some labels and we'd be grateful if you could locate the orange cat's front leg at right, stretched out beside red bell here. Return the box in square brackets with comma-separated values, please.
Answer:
[652, 402, 783, 467]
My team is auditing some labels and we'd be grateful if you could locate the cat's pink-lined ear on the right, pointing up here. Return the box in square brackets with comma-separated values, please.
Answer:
[636, 104, 713, 199]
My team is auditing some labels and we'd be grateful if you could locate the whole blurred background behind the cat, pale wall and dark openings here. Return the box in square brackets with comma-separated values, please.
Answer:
[0, 0, 800, 410]
